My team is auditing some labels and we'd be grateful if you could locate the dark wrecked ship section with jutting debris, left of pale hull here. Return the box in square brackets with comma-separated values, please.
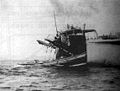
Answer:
[37, 24, 95, 67]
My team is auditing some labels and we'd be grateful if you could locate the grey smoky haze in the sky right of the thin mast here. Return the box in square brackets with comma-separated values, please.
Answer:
[50, 0, 120, 34]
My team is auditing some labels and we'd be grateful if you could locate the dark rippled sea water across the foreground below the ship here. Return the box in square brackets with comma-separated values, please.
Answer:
[0, 61, 120, 91]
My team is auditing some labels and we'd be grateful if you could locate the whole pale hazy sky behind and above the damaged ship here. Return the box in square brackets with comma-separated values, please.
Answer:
[0, 0, 120, 60]
